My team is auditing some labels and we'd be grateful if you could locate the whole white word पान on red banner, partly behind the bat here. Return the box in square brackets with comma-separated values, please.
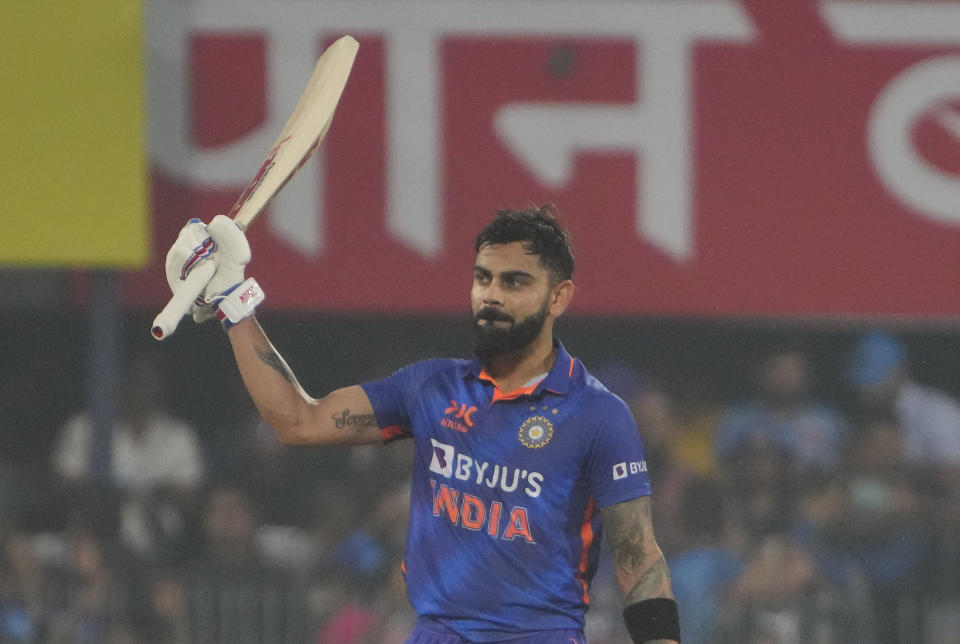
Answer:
[146, 0, 753, 260]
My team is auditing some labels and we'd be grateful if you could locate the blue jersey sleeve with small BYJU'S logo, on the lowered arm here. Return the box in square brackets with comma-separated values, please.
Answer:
[587, 395, 650, 508]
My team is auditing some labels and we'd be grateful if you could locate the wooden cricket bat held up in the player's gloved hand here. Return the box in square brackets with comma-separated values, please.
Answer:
[151, 36, 359, 340]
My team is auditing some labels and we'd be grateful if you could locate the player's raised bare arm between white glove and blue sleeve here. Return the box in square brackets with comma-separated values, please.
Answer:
[227, 316, 382, 445]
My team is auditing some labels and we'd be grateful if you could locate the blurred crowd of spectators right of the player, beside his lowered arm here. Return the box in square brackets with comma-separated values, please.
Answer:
[592, 331, 960, 644]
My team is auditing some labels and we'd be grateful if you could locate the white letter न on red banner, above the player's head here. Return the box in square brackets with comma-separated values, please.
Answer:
[496, 3, 753, 260]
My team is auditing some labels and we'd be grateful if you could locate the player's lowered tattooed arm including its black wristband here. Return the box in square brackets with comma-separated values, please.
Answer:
[601, 496, 680, 644]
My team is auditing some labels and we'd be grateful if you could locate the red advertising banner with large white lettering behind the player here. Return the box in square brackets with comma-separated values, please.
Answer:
[126, 0, 960, 317]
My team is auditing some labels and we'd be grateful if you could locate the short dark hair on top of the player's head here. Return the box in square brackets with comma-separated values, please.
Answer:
[474, 204, 575, 282]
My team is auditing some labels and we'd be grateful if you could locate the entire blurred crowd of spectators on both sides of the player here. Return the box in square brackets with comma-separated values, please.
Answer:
[0, 331, 960, 644]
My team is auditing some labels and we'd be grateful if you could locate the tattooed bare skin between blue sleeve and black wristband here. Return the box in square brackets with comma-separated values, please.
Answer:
[603, 499, 672, 604]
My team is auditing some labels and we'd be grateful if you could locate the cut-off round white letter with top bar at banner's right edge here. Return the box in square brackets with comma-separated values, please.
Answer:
[822, 0, 960, 225]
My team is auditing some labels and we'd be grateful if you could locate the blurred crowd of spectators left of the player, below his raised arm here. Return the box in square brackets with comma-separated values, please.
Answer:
[0, 340, 414, 644]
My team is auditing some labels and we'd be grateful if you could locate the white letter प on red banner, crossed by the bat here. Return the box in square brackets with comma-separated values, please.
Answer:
[145, 0, 324, 256]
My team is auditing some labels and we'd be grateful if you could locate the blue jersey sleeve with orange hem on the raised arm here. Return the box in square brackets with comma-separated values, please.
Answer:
[360, 360, 438, 440]
